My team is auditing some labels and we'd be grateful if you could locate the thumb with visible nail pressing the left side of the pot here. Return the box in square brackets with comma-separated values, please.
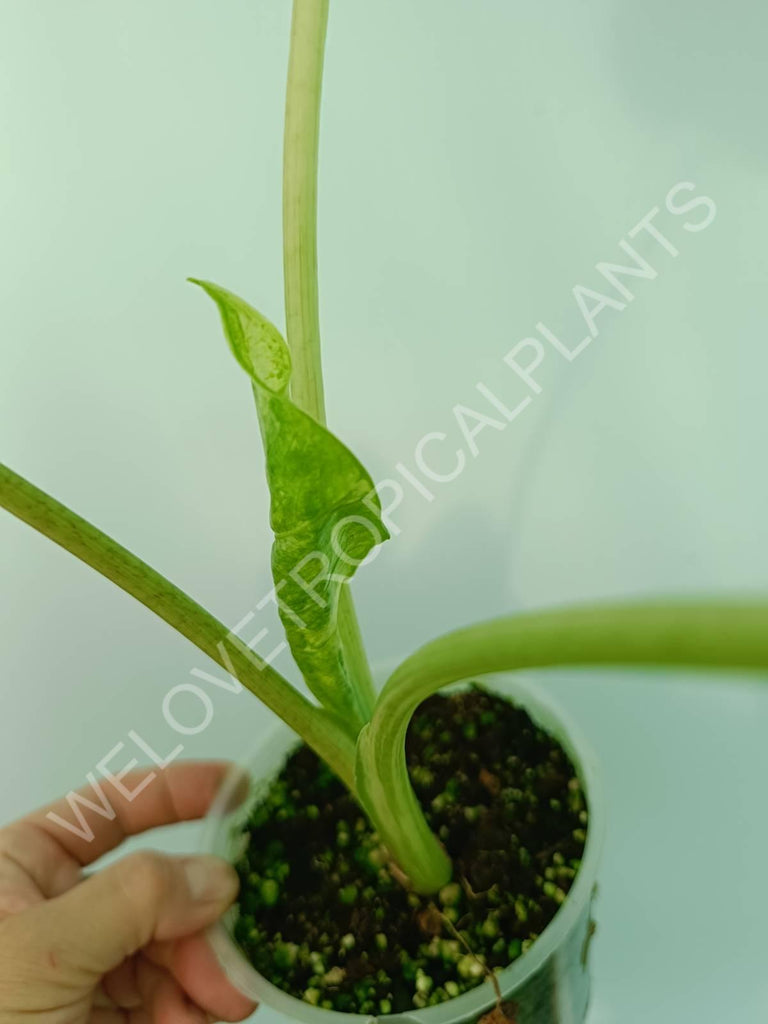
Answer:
[35, 851, 238, 976]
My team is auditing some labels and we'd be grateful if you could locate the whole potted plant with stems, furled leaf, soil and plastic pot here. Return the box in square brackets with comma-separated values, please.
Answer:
[0, 0, 768, 1024]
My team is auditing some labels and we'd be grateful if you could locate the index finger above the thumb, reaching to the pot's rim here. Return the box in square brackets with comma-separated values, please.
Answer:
[22, 761, 236, 864]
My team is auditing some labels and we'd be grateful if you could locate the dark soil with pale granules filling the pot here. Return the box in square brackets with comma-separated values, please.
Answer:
[236, 686, 587, 1014]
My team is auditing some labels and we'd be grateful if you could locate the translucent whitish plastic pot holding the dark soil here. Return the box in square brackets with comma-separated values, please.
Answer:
[204, 674, 605, 1024]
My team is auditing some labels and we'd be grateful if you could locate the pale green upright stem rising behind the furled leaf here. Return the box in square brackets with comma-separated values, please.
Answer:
[283, 0, 376, 721]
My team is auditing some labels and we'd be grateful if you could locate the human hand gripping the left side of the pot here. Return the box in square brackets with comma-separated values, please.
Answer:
[0, 762, 255, 1024]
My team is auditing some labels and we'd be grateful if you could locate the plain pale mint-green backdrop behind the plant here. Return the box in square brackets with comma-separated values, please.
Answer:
[0, 0, 768, 1024]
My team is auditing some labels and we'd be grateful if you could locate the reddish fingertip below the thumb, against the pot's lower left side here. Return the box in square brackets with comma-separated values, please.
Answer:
[144, 934, 258, 1021]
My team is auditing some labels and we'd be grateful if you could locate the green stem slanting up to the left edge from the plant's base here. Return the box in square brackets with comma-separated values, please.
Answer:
[0, 464, 354, 792]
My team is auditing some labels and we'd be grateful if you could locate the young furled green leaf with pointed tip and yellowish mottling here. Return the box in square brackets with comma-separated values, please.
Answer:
[190, 279, 389, 727]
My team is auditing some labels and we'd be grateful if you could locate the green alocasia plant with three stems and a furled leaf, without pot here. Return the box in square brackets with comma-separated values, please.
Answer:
[0, 0, 768, 893]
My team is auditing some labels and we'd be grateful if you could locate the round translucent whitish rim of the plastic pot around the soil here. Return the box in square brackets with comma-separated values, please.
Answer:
[203, 673, 605, 1024]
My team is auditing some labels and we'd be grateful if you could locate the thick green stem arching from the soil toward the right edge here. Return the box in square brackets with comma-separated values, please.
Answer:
[356, 601, 768, 892]
